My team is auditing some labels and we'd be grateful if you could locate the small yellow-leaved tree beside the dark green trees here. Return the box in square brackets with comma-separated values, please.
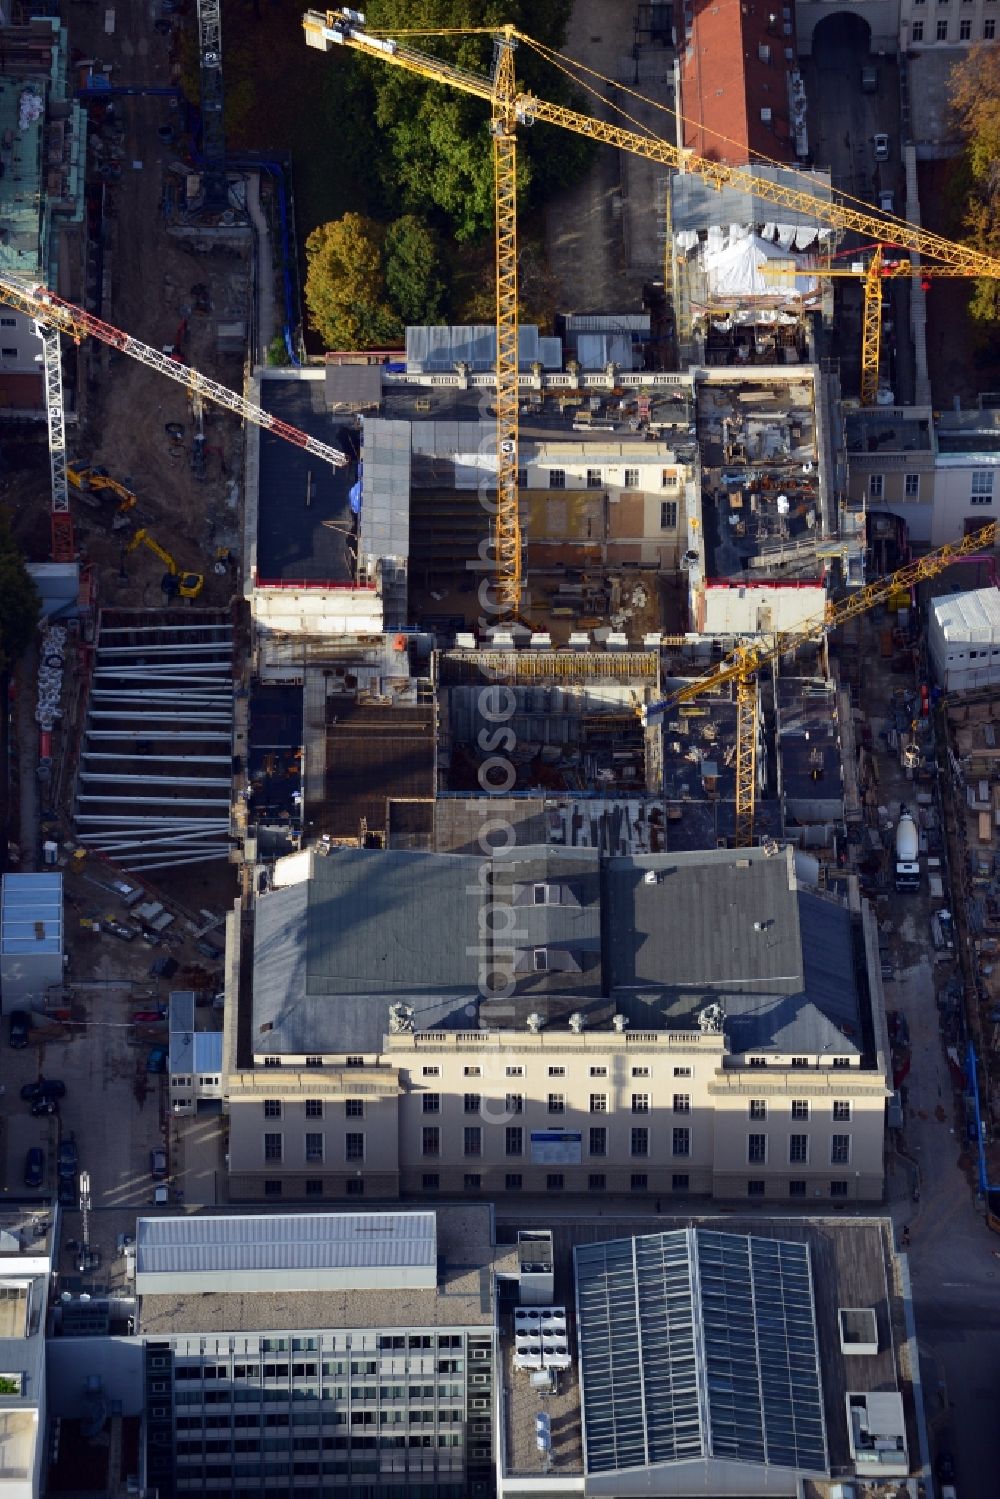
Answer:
[306, 213, 403, 349]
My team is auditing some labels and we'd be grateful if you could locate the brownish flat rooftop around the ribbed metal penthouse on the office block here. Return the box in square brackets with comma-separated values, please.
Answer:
[136, 1204, 496, 1336]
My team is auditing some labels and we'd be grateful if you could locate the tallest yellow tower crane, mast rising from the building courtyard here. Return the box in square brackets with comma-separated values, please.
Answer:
[303, 6, 1000, 616]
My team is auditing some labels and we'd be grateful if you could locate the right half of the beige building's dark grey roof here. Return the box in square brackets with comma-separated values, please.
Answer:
[604, 848, 861, 1055]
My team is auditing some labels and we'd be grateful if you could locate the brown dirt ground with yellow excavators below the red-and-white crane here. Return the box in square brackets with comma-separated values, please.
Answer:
[33, 0, 249, 607]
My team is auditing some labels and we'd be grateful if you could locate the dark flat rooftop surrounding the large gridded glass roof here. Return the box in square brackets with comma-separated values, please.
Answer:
[501, 1216, 919, 1477]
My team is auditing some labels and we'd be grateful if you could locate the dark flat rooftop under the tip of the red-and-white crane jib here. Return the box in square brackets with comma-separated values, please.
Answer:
[256, 379, 357, 583]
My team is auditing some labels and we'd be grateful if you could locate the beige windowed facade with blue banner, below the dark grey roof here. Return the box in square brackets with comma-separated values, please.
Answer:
[226, 1025, 888, 1205]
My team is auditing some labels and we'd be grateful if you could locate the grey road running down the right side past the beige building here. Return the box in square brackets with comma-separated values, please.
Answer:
[864, 616, 1000, 1499]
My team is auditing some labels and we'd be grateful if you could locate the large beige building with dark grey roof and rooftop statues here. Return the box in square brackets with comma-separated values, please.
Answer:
[223, 845, 889, 1205]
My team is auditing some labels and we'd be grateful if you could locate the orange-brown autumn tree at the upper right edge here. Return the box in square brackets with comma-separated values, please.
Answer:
[949, 43, 1000, 322]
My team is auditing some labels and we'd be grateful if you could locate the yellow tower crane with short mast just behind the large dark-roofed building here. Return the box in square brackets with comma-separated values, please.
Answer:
[642, 522, 997, 848]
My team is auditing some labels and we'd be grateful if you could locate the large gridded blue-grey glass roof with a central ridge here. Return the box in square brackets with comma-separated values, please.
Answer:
[574, 1229, 829, 1492]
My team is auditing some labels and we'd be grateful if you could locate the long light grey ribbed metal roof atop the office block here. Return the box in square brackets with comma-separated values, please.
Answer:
[135, 1213, 438, 1292]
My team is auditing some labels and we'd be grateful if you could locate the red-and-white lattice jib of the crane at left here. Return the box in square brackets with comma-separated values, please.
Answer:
[0, 274, 348, 468]
